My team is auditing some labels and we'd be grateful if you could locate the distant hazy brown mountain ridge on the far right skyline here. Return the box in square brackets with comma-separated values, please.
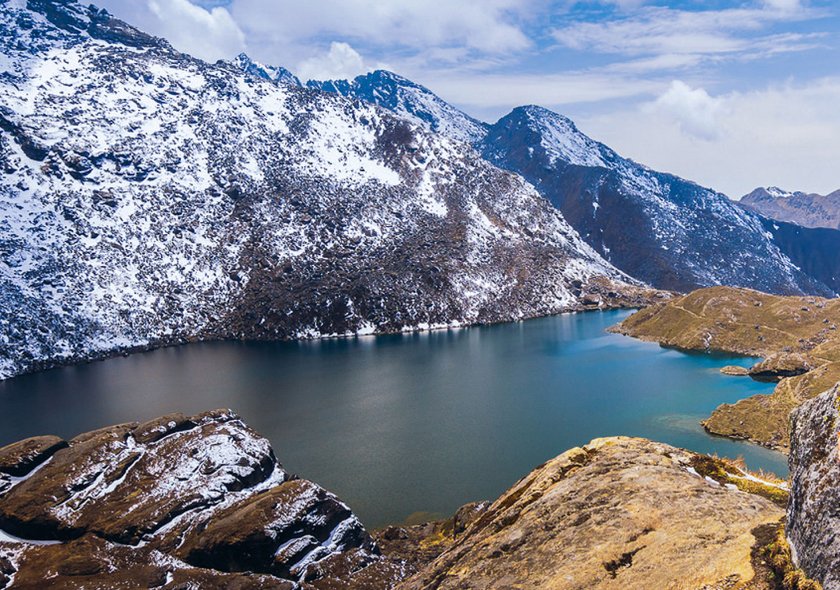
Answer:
[738, 187, 840, 229]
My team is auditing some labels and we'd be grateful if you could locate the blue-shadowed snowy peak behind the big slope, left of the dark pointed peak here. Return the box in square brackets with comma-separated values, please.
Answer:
[307, 70, 488, 143]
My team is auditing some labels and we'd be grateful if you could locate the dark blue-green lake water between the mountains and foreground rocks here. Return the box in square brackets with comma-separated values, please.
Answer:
[0, 312, 787, 527]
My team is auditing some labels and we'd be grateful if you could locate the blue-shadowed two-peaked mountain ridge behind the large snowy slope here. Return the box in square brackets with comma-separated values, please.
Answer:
[296, 72, 836, 295]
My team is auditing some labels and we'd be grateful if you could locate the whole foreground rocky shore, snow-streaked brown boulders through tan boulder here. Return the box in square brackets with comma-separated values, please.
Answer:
[0, 410, 828, 590]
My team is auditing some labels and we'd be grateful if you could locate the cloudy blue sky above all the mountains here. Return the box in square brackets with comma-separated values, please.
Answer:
[101, 0, 840, 197]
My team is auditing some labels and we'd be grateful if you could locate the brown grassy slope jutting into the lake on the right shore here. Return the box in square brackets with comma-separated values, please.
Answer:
[614, 287, 840, 450]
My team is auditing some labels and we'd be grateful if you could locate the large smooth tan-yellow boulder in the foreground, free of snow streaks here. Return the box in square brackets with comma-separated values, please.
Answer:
[400, 437, 784, 590]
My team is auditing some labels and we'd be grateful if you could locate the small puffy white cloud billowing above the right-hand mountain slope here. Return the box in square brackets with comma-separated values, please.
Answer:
[649, 80, 724, 140]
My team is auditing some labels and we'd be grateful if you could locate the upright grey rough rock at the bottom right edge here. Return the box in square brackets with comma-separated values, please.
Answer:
[787, 386, 840, 590]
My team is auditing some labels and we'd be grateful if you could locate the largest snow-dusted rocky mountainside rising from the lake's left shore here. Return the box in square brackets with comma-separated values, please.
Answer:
[0, 0, 644, 378]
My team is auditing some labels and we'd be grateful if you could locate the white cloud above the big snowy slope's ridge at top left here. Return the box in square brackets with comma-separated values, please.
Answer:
[97, 0, 245, 61]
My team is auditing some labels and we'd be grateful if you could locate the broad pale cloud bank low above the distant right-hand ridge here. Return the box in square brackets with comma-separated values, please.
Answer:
[577, 77, 840, 197]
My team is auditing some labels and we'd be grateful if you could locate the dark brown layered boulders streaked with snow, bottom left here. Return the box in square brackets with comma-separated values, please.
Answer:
[0, 411, 408, 590]
